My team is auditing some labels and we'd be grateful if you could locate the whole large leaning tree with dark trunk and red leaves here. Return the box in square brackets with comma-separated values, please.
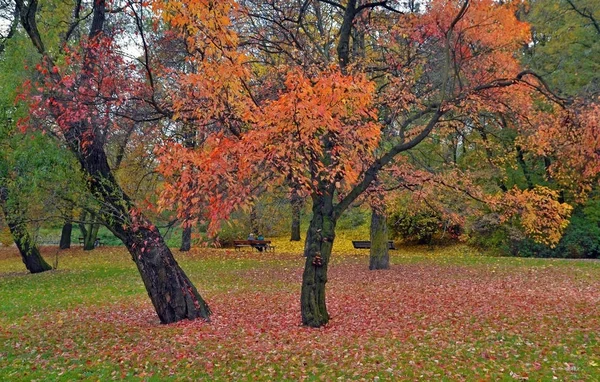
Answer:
[17, 0, 210, 323]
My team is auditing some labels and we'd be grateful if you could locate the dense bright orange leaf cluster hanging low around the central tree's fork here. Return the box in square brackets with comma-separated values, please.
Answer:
[158, 70, 380, 228]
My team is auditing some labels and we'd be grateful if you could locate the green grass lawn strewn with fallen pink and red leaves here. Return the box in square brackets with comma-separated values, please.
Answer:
[0, 243, 600, 381]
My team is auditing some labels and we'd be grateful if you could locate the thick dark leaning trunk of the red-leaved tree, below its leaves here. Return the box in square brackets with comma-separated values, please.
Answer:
[66, 130, 211, 324]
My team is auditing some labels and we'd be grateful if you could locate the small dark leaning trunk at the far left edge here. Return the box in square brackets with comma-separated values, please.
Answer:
[0, 187, 52, 273]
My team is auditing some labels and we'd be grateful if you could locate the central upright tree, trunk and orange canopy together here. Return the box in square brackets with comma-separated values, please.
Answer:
[155, 0, 562, 327]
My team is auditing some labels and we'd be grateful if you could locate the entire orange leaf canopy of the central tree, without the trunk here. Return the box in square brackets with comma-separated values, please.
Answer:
[152, 0, 580, 248]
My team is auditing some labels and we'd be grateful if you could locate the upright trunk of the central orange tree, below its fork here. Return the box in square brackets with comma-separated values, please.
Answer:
[300, 194, 336, 328]
